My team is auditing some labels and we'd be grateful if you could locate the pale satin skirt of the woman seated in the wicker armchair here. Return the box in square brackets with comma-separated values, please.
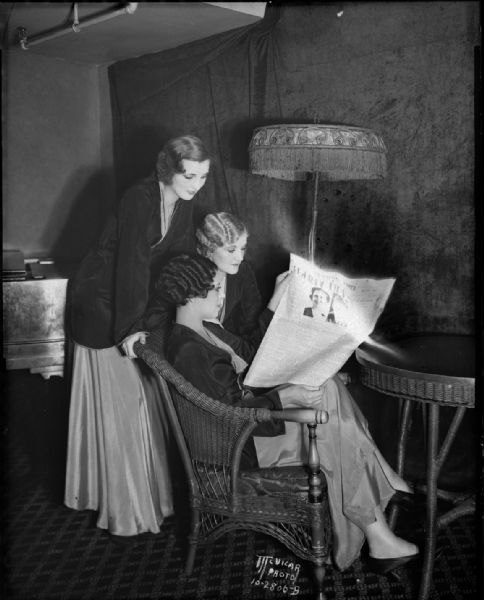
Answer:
[254, 377, 395, 570]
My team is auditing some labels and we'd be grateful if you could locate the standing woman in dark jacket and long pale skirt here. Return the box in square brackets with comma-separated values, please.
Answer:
[65, 135, 210, 536]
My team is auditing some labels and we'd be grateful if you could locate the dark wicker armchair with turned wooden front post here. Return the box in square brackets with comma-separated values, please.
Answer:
[135, 343, 331, 600]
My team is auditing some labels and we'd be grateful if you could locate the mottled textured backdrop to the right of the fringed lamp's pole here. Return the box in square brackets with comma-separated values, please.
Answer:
[277, 2, 479, 332]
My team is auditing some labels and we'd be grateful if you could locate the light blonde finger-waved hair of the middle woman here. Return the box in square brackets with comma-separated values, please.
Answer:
[195, 212, 247, 256]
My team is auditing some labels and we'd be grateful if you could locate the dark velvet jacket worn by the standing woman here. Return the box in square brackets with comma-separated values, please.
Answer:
[69, 175, 195, 348]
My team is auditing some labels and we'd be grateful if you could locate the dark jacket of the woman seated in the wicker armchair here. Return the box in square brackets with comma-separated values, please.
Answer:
[166, 324, 285, 468]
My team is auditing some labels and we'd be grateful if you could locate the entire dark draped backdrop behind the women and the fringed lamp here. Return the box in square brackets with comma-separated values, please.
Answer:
[110, 2, 479, 334]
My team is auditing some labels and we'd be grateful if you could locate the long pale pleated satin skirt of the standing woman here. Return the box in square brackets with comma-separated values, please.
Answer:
[64, 344, 173, 536]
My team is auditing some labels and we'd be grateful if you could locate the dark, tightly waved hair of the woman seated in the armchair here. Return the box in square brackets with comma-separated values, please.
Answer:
[156, 254, 217, 306]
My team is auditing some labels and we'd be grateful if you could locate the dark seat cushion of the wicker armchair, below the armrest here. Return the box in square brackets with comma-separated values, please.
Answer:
[239, 466, 326, 496]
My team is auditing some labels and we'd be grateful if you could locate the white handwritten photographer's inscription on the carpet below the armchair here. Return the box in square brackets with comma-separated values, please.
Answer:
[250, 555, 301, 597]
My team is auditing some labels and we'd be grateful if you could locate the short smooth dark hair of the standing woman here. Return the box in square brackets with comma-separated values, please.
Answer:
[156, 135, 210, 185]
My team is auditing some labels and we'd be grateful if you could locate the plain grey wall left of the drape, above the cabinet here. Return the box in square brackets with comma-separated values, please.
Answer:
[2, 48, 114, 259]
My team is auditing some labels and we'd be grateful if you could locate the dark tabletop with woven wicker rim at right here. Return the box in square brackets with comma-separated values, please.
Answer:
[355, 334, 475, 407]
